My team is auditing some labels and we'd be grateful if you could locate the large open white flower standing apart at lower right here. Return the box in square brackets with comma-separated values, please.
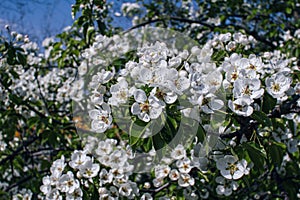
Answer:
[217, 155, 249, 180]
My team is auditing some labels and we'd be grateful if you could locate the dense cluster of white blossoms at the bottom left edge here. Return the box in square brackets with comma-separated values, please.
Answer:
[41, 137, 139, 199]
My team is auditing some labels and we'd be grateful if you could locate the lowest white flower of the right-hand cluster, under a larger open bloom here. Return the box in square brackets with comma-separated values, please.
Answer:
[228, 96, 253, 117]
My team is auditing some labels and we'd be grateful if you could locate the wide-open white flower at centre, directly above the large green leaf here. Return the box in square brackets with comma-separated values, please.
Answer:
[131, 89, 163, 122]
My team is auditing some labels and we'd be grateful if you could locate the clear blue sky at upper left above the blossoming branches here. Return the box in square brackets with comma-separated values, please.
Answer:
[0, 0, 134, 42]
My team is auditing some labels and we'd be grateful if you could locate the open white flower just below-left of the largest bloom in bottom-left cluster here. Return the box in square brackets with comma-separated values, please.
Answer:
[57, 171, 80, 193]
